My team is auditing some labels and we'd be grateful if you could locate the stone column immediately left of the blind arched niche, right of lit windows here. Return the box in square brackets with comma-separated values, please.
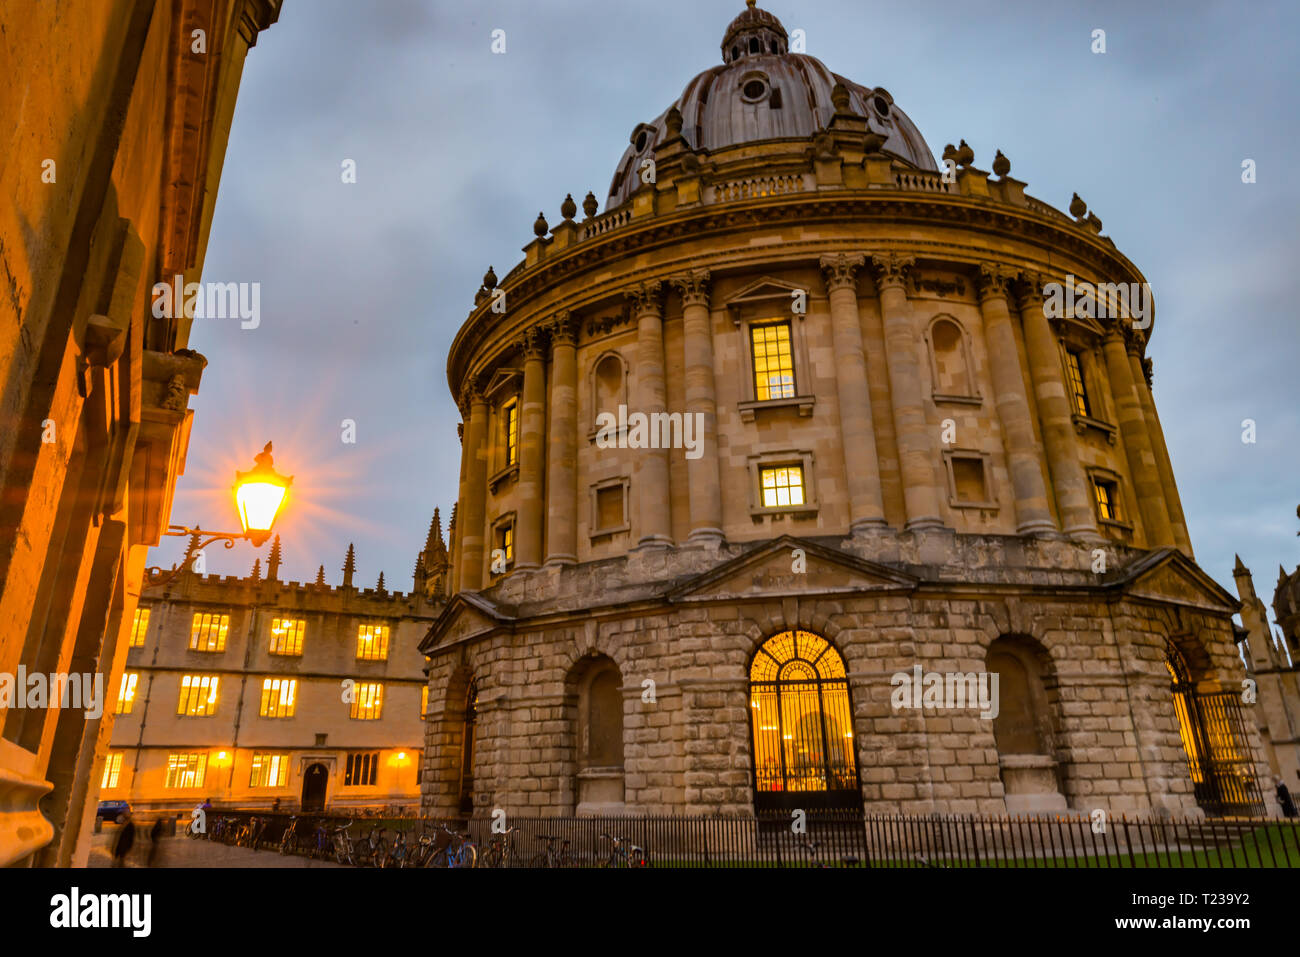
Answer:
[871, 254, 944, 529]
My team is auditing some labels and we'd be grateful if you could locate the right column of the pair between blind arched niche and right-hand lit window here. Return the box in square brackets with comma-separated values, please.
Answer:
[1019, 274, 1101, 541]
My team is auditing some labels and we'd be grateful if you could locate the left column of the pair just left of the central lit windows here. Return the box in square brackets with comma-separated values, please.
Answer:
[625, 280, 672, 547]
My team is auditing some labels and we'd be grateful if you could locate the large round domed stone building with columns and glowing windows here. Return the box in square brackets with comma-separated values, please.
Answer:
[421, 4, 1273, 814]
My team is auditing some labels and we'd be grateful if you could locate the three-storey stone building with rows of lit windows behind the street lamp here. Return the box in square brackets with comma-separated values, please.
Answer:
[99, 515, 447, 814]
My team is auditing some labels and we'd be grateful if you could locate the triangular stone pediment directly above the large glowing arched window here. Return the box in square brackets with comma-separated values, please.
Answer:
[668, 536, 917, 602]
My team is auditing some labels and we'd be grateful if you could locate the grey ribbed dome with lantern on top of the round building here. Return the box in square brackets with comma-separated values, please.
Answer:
[605, 0, 939, 209]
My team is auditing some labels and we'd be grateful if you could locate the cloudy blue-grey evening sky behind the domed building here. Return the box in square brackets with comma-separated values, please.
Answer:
[153, 0, 1300, 624]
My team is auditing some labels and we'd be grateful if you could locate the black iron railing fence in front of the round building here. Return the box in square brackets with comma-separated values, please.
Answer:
[181, 810, 1300, 869]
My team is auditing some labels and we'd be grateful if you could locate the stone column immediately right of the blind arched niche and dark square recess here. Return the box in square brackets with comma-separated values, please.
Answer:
[976, 263, 1056, 534]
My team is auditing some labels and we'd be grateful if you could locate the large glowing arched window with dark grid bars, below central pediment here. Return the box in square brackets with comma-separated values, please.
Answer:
[749, 631, 862, 810]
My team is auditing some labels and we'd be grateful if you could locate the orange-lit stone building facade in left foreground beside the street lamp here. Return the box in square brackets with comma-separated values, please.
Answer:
[0, 0, 281, 866]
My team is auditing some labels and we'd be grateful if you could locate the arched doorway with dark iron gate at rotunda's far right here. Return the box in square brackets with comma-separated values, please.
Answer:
[1165, 641, 1264, 815]
